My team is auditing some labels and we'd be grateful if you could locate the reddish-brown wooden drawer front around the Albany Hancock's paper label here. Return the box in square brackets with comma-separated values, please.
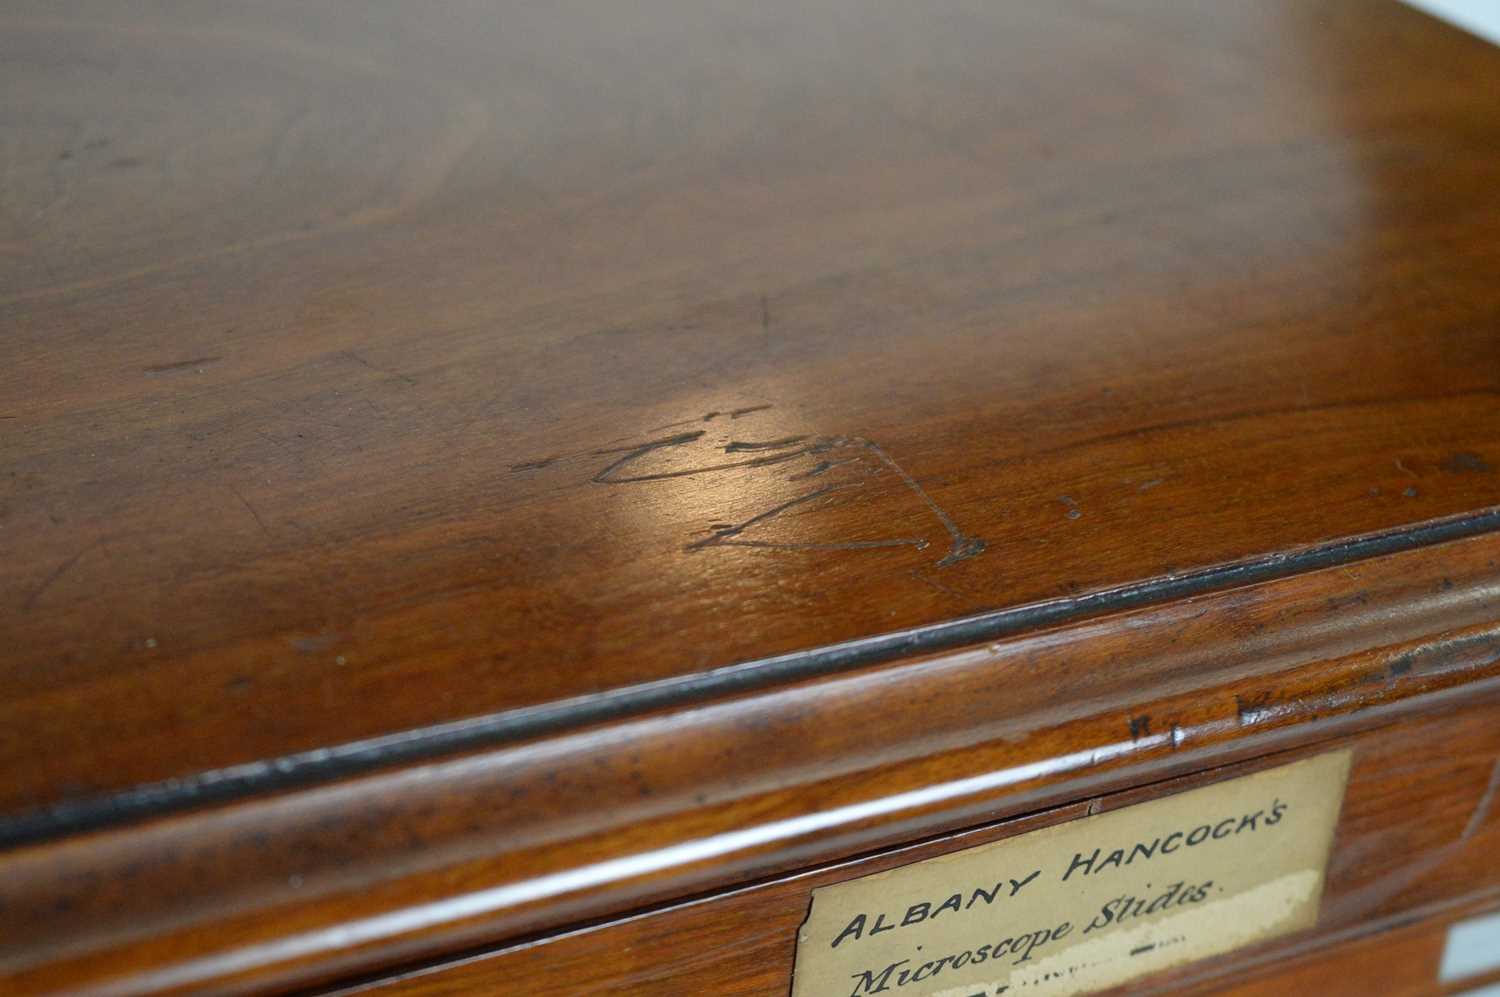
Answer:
[345, 702, 1500, 997]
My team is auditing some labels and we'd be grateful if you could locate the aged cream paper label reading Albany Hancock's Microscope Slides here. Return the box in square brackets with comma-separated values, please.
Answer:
[792, 751, 1349, 997]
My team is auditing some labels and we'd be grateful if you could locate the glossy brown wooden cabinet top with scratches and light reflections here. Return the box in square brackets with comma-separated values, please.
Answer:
[0, 0, 1500, 831]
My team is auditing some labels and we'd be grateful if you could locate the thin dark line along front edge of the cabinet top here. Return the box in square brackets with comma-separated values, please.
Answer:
[0, 507, 1500, 847]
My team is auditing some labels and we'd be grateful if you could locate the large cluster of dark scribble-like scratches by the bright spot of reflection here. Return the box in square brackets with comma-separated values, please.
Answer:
[510, 405, 984, 568]
